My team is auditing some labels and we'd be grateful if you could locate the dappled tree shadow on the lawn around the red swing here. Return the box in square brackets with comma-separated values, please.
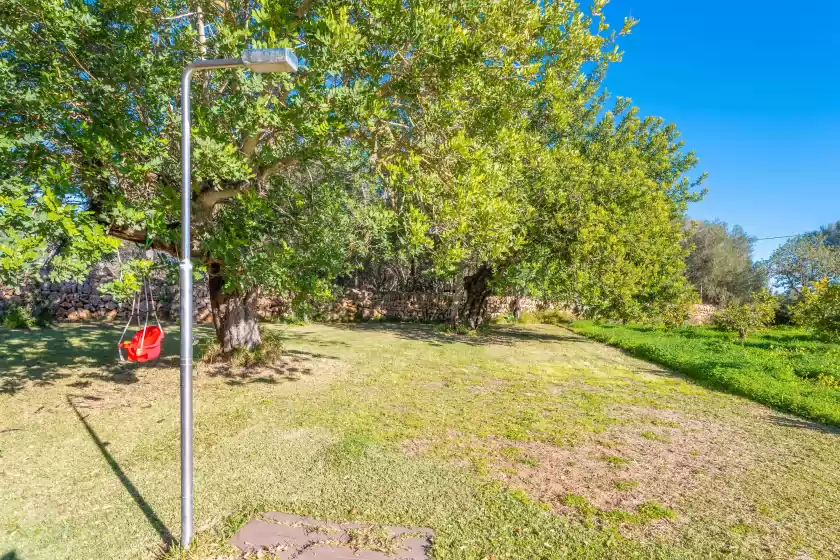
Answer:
[0, 323, 215, 394]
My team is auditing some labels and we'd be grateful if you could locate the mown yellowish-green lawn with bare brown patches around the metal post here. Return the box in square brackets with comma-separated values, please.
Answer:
[0, 324, 840, 560]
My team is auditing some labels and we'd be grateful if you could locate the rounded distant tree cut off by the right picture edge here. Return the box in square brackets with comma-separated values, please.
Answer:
[766, 232, 840, 296]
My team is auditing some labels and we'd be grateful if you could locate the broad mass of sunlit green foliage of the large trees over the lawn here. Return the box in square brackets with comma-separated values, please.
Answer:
[0, 0, 702, 345]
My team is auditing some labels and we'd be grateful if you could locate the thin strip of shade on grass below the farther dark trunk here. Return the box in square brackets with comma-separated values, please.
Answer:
[324, 322, 585, 346]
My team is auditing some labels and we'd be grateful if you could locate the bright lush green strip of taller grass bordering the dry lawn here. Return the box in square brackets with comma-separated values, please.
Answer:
[572, 321, 840, 426]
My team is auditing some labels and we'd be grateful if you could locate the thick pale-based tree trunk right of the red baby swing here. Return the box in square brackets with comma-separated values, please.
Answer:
[209, 264, 262, 353]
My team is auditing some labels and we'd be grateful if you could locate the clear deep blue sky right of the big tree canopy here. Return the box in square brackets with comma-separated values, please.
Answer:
[606, 0, 840, 259]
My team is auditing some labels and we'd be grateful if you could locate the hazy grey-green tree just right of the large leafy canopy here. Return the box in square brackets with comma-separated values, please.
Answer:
[686, 220, 767, 305]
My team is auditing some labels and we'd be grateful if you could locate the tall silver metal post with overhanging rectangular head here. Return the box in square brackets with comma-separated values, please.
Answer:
[179, 49, 298, 548]
